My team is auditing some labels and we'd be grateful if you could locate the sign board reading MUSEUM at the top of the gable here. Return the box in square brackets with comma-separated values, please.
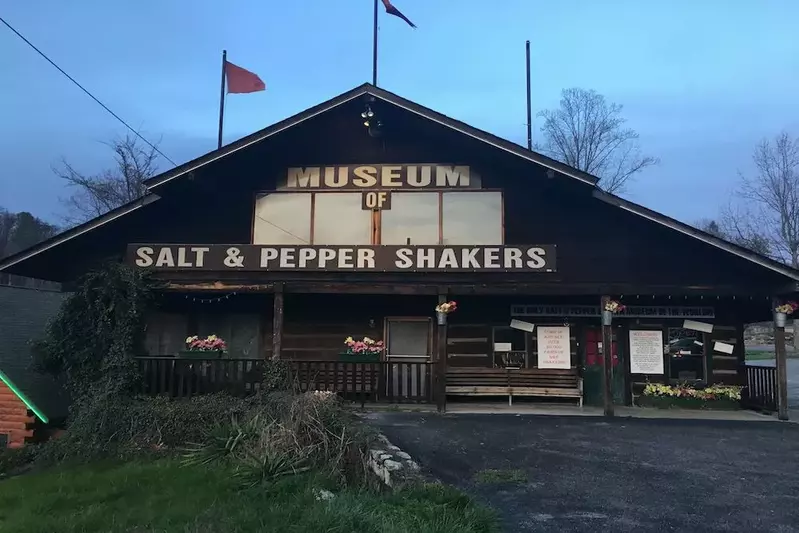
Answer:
[278, 163, 480, 191]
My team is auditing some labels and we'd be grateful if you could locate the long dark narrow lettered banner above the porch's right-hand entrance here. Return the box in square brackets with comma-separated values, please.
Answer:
[510, 305, 716, 318]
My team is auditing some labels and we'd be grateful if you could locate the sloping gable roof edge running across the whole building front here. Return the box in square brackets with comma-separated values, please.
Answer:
[0, 83, 799, 281]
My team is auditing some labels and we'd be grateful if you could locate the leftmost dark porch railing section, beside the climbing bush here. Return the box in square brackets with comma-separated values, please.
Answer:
[136, 357, 264, 398]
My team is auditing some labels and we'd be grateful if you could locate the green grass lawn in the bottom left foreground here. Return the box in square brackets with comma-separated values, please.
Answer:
[0, 460, 496, 533]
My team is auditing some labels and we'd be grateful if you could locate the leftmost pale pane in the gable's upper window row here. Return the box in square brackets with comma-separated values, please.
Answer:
[253, 193, 311, 244]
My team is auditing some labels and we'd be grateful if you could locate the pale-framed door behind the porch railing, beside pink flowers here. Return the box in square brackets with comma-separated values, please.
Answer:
[385, 317, 433, 399]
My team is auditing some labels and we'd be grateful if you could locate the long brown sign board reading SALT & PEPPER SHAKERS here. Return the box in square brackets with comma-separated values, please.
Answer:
[127, 244, 556, 272]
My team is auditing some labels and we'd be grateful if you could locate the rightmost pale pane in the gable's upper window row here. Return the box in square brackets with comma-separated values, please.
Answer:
[441, 191, 503, 244]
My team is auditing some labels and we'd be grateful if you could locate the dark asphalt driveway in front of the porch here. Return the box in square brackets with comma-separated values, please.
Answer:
[369, 413, 799, 533]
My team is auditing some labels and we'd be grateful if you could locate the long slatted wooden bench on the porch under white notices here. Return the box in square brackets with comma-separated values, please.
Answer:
[446, 368, 583, 407]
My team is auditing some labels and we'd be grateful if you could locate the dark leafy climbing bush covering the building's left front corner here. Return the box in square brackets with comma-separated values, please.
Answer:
[33, 263, 155, 400]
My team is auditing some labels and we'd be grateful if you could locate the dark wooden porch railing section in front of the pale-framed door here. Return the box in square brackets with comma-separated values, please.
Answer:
[292, 361, 434, 404]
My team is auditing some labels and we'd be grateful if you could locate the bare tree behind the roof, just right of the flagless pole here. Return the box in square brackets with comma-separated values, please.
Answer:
[538, 88, 658, 193]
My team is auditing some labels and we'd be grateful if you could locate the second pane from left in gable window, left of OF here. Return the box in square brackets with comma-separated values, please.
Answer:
[313, 192, 372, 244]
